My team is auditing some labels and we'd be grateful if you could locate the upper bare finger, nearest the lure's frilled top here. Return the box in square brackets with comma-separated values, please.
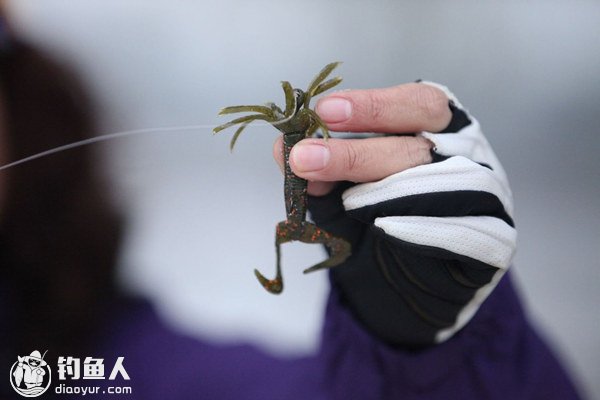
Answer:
[315, 83, 452, 133]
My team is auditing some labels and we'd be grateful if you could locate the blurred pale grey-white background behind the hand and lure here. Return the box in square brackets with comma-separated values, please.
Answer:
[7, 0, 600, 398]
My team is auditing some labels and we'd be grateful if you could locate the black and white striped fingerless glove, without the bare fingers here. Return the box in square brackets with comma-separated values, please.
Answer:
[309, 82, 516, 346]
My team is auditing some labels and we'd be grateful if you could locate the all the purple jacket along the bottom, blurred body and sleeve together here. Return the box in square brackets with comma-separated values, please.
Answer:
[88, 275, 578, 400]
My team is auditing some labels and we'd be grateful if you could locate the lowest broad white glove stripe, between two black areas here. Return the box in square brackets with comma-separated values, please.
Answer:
[375, 216, 517, 269]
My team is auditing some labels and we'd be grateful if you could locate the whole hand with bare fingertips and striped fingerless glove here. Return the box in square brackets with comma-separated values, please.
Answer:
[276, 83, 516, 345]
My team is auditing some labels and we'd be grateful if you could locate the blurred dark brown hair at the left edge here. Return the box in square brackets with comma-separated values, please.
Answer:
[0, 41, 121, 357]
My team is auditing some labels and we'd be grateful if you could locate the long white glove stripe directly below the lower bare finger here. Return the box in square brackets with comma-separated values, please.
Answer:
[342, 156, 513, 217]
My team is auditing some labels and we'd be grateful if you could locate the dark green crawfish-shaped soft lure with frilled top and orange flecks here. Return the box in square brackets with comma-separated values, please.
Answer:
[213, 62, 350, 294]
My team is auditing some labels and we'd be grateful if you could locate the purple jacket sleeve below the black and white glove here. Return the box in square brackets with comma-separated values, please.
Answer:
[319, 275, 579, 400]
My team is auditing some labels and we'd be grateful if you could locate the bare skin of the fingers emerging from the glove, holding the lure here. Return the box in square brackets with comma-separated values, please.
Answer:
[273, 83, 452, 196]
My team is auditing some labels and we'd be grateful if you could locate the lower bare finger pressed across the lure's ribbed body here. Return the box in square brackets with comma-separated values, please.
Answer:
[290, 136, 433, 182]
